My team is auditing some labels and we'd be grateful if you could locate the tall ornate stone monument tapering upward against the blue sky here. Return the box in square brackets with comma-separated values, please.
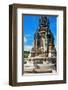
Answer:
[31, 16, 56, 57]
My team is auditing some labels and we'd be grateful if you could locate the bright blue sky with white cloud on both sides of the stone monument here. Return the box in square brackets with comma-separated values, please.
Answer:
[23, 15, 57, 50]
